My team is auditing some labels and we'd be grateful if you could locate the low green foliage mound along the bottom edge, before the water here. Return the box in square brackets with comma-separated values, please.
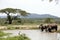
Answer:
[0, 34, 30, 40]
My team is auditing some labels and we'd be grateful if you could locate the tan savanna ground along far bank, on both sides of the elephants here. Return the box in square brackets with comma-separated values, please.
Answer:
[0, 24, 60, 32]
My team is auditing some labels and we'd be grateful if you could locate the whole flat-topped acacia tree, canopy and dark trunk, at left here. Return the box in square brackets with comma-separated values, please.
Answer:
[0, 8, 28, 24]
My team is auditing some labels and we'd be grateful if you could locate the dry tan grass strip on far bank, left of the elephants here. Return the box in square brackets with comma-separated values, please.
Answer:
[0, 24, 39, 29]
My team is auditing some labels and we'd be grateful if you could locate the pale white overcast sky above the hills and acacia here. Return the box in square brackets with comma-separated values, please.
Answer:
[0, 0, 60, 17]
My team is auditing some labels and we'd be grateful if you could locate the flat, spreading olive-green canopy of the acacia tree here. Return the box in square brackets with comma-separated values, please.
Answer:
[0, 8, 28, 16]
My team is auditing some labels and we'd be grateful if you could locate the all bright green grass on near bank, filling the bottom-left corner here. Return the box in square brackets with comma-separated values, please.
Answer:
[0, 31, 30, 40]
